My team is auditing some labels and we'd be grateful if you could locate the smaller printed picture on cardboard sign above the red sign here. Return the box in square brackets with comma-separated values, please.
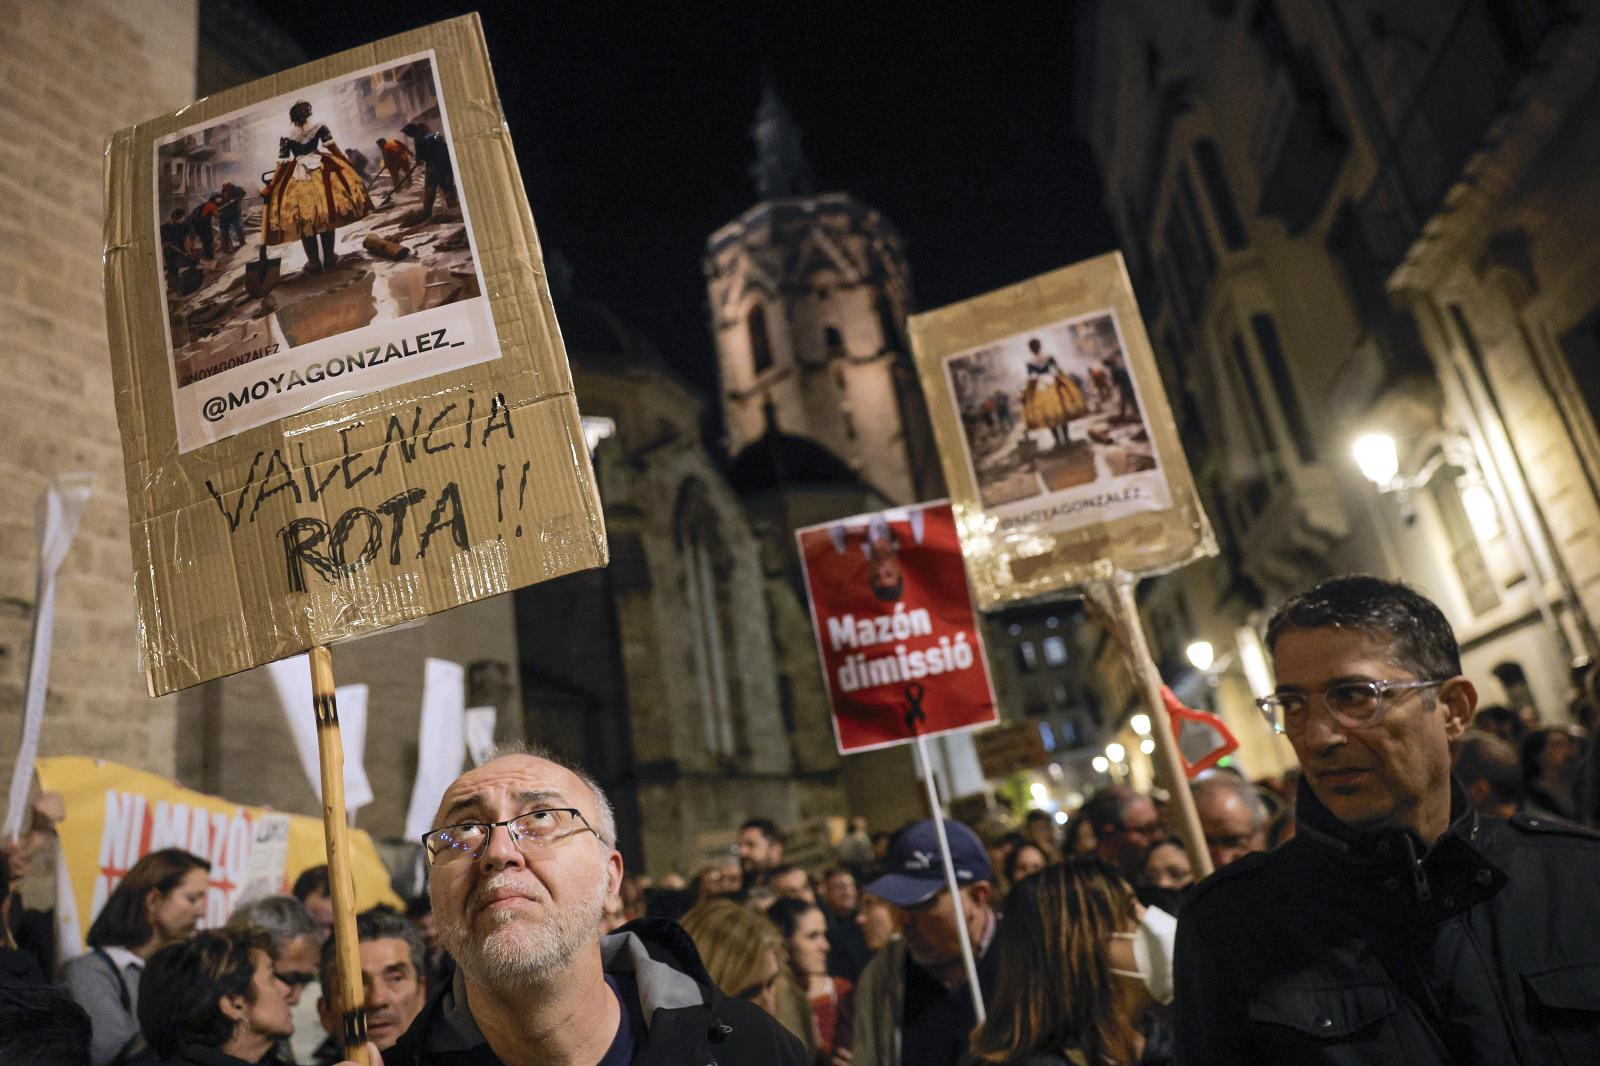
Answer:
[944, 309, 1171, 530]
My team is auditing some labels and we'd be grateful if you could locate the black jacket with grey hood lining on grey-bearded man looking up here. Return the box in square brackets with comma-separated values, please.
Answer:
[384, 919, 805, 1066]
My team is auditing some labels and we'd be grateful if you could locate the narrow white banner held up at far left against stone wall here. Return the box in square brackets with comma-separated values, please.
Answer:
[0, 474, 94, 840]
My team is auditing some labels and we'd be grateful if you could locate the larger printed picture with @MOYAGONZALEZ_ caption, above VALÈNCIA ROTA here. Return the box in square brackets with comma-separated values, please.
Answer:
[155, 51, 499, 451]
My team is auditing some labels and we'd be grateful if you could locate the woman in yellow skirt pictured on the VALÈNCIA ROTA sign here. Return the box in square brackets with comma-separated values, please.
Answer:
[261, 101, 373, 274]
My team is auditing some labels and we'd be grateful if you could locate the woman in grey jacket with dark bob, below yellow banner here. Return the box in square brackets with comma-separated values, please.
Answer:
[61, 848, 211, 1066]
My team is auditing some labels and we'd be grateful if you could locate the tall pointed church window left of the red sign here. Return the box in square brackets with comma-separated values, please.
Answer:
[675, 482, 739, 755]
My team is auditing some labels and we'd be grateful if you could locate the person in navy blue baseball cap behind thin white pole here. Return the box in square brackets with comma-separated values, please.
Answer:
[853, 820, 1000, 1066]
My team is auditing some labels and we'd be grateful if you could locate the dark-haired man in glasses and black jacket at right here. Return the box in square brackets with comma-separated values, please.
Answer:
[1176, 576, 1600, 1066]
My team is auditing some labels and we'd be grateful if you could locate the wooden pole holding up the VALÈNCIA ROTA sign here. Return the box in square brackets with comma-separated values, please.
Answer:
[309, 643, 366, 1066]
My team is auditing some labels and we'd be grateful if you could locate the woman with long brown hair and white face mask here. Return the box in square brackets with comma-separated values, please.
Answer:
[970, 860, 1170, 1066]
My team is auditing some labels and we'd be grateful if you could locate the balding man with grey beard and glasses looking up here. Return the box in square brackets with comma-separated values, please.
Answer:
[355, 752, 802, 1066]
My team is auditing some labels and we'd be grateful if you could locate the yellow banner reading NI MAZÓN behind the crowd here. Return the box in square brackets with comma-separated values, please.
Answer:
[35, 755, 403, 936]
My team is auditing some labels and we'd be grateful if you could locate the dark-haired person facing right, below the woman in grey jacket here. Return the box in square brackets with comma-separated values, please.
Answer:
[139, 927, 294, 1066]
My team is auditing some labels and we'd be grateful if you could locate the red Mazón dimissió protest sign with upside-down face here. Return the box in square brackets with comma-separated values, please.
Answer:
[795, 501, 1000, 754]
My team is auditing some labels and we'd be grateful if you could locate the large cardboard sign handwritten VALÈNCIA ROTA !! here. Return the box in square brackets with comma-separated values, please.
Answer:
[106, 16, 605, 695]
